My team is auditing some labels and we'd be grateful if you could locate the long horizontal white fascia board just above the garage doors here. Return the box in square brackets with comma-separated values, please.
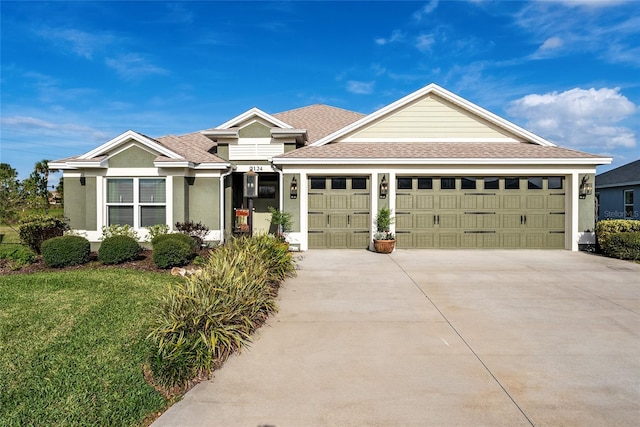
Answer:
[273, 157, 612, 165]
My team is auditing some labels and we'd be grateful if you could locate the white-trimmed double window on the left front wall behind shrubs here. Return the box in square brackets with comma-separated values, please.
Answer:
[106, 178, 167, 228]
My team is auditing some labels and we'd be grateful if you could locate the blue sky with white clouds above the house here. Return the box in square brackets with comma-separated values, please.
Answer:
[0, 0, 640, 186]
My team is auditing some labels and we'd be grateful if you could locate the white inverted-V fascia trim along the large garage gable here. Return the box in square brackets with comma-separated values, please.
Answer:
[309, 83, 556, 147]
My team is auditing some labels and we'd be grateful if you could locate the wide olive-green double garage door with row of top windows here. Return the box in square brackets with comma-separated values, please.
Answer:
[396, 176, 565, 248]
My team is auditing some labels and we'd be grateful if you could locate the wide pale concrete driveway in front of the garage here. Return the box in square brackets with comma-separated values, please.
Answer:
[154, 250, 640, 427]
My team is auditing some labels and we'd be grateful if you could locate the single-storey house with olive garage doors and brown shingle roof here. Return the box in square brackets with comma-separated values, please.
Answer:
[49, 84, 611, 250]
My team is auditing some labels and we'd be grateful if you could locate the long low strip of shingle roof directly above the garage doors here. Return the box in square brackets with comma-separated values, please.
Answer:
[279, 142, 601, 159]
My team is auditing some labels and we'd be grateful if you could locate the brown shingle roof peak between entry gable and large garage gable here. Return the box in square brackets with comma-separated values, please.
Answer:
[273, 104, 365, 143]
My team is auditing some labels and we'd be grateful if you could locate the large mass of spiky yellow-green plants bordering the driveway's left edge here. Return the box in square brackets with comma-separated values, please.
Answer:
[148, 236, 294, 386]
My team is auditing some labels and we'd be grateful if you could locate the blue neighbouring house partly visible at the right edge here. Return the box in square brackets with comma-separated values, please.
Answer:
[596, 159, 640, 220]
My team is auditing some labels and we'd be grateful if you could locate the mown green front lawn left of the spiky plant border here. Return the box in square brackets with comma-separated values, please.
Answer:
[0, 269, 175, 426]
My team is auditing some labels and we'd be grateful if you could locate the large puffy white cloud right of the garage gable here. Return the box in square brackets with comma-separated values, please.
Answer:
[507, 88, 638, 150]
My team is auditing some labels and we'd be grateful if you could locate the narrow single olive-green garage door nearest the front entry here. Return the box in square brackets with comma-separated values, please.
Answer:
[309, 176, 371, 249]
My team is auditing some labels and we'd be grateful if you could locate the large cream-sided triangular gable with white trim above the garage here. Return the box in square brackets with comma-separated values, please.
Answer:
[311, 83, 555, 146]
